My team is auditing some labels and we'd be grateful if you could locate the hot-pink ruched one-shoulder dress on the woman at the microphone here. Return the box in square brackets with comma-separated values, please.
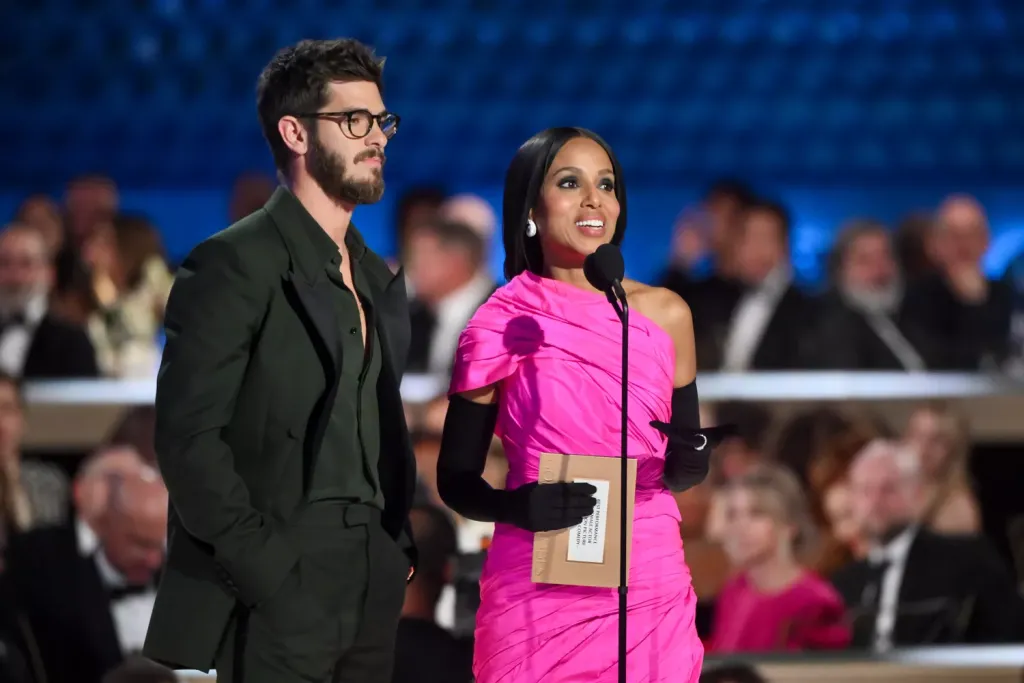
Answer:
[451, 273, 703, 683]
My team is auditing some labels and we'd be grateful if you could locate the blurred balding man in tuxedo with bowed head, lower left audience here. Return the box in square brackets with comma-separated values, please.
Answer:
[8, 468, 167, 683]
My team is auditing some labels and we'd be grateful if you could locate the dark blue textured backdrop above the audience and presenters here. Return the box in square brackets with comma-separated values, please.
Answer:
[0, 0, 1024, 187]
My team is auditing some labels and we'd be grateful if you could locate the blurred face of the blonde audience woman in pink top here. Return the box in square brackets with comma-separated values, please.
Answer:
[723, 488, 792, 569]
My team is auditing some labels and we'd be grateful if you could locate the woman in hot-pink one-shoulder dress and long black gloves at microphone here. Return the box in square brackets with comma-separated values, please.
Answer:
[437, 128, 714, 683]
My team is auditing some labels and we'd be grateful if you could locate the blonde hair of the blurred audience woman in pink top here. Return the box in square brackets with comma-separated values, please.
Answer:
[725, 463, 818, 563]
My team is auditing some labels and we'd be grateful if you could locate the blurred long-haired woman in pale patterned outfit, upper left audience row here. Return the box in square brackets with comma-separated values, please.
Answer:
[76, 216, 173, 377]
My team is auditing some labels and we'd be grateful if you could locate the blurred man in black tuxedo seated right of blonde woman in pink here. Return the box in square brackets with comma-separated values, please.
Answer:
[833, 439, 1024, 651]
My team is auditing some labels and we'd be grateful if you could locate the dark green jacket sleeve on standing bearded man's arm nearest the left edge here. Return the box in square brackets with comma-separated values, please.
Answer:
[156, 240, 298, 605]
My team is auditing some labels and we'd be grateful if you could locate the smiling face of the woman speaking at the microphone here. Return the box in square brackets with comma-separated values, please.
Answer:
[530, 137, 620, 267]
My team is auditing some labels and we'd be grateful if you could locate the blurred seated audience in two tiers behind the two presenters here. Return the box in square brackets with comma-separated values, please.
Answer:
[6, 173, 1024, 683]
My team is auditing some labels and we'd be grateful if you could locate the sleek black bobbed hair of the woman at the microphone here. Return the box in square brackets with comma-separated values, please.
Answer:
[502, 127, 626, 280]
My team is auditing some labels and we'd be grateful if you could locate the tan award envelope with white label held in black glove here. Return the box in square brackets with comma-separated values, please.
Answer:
[530, 453, 637, 588]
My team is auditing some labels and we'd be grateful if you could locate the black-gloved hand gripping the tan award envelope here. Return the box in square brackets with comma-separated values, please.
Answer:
[501, 481, 597, 532]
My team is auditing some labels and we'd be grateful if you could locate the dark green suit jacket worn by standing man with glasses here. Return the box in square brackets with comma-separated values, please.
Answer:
[143, 188, 416, 671]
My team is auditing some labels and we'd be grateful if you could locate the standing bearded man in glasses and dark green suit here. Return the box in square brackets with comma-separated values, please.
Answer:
[144, 40, 416, 683]
